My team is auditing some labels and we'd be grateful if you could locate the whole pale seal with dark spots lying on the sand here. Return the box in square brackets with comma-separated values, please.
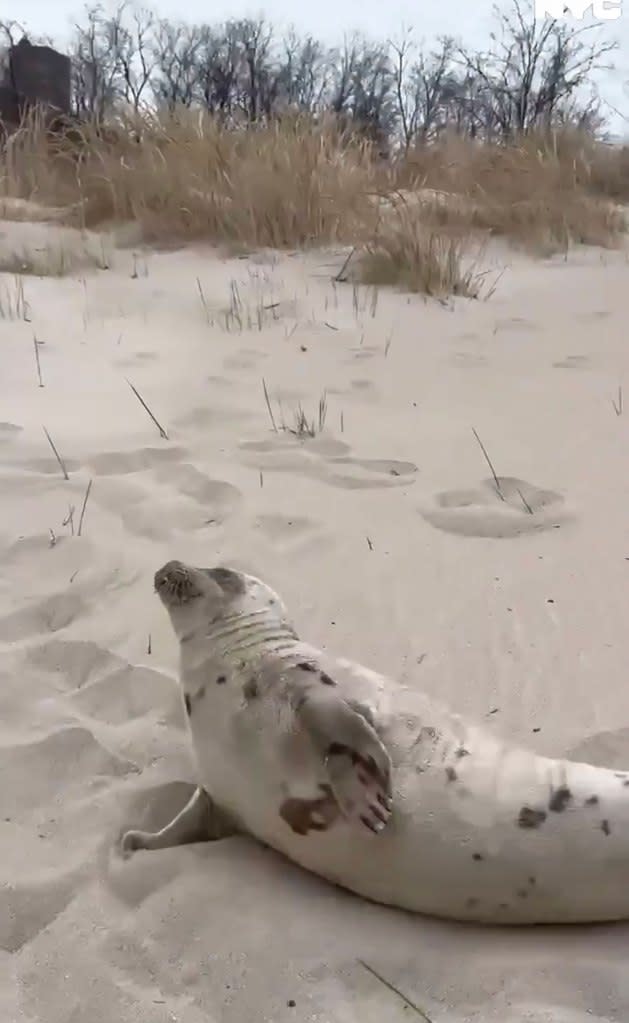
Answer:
[122, 561, 629, 925]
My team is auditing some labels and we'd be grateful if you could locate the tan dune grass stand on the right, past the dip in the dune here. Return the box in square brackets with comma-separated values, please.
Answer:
[398, 129, 629, 256]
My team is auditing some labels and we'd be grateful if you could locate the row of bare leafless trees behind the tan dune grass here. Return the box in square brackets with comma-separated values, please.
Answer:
[59, 0, 614, 144]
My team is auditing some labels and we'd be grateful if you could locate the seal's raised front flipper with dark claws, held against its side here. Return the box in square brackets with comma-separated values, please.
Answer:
[296, 688, 392, 832]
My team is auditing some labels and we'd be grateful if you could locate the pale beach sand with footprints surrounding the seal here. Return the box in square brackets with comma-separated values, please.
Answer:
[0, 213, 629, 1023]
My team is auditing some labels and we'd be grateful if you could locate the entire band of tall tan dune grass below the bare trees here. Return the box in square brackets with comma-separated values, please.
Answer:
[0, 109, 629, 297]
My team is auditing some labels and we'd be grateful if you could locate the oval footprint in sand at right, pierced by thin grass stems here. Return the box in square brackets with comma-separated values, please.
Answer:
[419, 476, 572, 539]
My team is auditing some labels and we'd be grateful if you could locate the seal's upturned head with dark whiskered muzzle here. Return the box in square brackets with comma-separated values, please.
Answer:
[153, 561, 287, 639]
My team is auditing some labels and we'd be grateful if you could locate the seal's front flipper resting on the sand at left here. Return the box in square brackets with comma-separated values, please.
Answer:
[120, 787, 237, 858]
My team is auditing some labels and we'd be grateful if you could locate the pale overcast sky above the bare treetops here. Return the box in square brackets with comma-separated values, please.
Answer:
[8, 0, 629, 135]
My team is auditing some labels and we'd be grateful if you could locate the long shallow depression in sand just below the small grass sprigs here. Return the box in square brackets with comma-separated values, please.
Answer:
[239, 431, 417, 490]
